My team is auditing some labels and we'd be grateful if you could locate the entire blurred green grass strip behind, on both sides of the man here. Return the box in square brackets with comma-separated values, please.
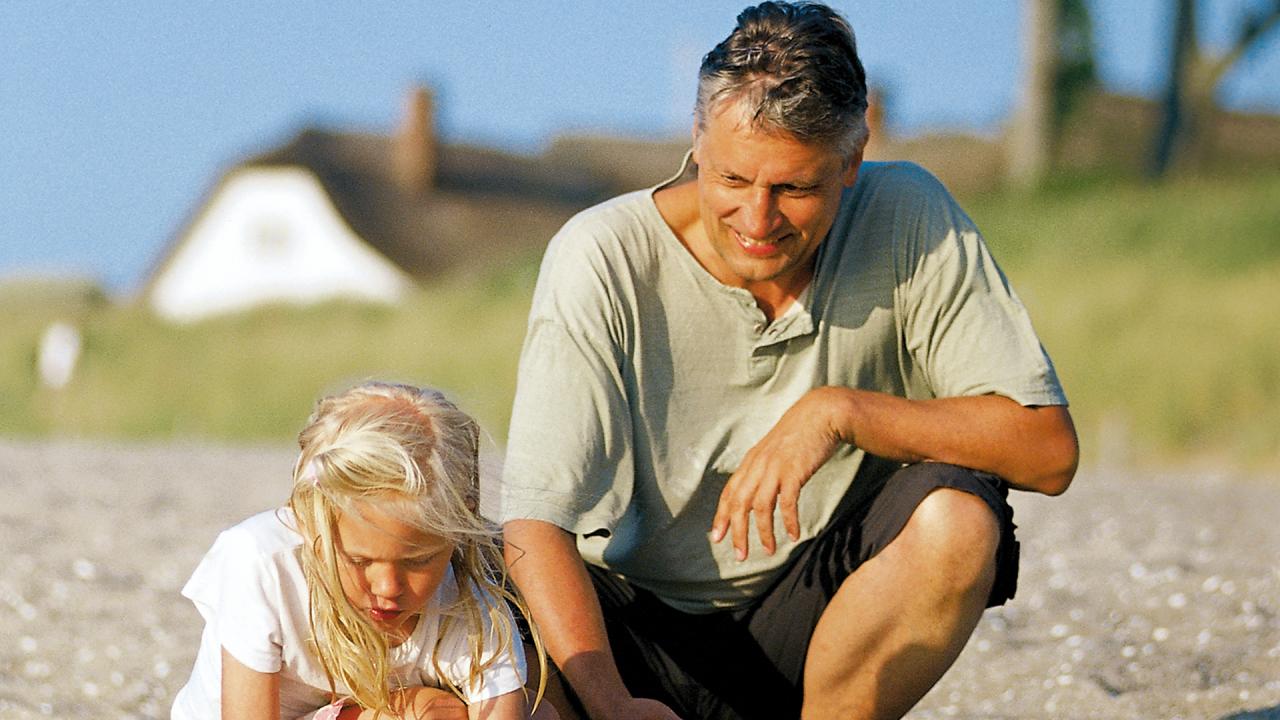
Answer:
[0, 173, 1280, 468]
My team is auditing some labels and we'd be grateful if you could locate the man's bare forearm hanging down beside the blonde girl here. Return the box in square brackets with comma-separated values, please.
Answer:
[503, 520, 677, 720]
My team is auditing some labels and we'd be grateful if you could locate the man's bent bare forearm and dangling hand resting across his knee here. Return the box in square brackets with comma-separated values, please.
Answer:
[712, 387, 1079, 559]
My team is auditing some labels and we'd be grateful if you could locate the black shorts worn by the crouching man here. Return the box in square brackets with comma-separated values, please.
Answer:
[576, 456, 1018, 719]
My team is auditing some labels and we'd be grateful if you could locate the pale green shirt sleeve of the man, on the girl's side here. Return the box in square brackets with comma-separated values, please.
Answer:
[498, 215, 634, 534]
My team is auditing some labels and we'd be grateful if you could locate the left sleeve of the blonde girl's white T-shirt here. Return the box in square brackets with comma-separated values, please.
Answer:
[182, 517, 283, 673]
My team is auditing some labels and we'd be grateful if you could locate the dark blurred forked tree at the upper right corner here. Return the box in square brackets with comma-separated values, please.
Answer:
[1151, 0, 1280, 177]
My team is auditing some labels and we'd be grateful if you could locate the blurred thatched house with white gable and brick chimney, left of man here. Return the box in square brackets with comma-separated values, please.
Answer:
[143, 90, 678, 320]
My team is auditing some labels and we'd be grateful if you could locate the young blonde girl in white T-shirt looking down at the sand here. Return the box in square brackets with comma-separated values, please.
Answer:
[173, 383, 554, 719]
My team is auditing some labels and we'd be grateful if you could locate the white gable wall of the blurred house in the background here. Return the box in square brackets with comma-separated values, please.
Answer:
[150, 168, 412, 322]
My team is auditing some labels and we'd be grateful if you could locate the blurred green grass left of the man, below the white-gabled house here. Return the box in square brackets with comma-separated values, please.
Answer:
[0, 252, 536, 439]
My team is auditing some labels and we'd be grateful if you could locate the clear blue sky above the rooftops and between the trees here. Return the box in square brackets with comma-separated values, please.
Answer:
[0, 0, 1280, 292]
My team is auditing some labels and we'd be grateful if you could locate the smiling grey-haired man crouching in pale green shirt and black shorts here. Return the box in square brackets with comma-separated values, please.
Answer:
[502, 3, 1078, 719]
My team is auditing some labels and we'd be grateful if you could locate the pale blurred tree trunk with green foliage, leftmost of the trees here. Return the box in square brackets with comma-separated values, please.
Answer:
[1007, 0, 1097, 186]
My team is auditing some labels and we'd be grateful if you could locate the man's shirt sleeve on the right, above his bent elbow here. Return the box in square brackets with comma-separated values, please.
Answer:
[900, 165, 1066, 406]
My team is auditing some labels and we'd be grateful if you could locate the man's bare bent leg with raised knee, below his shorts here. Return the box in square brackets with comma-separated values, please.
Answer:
[803, 487, 1002, 720]
